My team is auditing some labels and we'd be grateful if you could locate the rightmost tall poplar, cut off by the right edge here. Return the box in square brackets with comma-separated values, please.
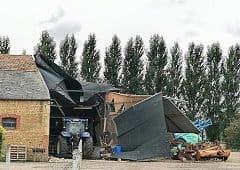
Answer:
[221, 44, 240, 134]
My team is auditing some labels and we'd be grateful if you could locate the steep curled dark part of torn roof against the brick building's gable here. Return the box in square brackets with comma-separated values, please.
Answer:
[35, 55, 83, 105]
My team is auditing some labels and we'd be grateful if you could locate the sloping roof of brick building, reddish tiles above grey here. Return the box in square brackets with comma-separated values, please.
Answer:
[0, 54, 50, 100]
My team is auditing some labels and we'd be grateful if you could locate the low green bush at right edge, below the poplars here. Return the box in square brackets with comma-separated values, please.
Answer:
[224, 113, 240, 150]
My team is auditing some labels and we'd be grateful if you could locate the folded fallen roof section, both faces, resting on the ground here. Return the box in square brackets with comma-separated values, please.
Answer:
[113, 94, 199, 160]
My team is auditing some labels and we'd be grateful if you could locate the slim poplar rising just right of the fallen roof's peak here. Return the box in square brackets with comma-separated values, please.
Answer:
[166, 42, 182, 98]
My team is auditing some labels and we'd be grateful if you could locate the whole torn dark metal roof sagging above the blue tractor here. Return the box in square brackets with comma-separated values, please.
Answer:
[35, 55, 119, 106]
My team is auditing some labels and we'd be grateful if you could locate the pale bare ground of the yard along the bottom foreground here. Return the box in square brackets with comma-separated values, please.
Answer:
[0, 152, 240, 170]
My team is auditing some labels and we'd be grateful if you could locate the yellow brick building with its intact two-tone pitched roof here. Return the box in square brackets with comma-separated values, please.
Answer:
[0, 55, 50, 160]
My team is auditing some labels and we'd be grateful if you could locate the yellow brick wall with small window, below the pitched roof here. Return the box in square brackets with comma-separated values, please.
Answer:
[0, 100, 50, 161]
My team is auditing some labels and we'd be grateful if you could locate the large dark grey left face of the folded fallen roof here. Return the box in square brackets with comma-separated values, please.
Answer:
[114, 94, 170, 160]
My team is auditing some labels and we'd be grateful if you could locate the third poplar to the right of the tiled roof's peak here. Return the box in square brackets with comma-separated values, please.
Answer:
[80, 34, 101, 82]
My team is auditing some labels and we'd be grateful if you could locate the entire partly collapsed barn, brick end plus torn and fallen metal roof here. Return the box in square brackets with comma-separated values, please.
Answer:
[0, 54, 198, 161]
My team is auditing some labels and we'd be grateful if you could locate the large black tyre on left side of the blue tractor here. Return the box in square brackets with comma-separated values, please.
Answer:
[57, 136, 71, 158]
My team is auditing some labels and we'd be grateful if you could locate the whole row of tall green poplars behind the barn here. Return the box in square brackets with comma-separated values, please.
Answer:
[0, 31, 240, 145]
